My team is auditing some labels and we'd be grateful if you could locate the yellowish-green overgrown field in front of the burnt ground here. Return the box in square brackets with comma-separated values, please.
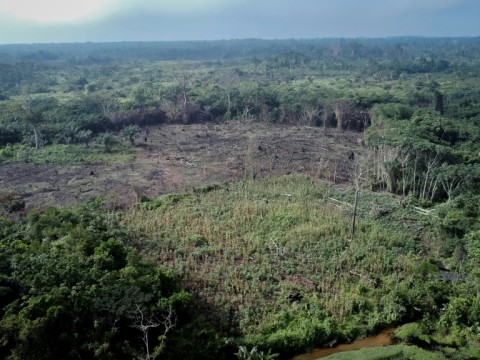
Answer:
[123, 175, 428, 351]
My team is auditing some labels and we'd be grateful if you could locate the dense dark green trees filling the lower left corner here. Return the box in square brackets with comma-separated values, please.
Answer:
[0, 202, 199, 359]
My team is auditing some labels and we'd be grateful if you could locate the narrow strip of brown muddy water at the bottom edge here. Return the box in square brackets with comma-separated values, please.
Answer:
[292, 327, 396, 360]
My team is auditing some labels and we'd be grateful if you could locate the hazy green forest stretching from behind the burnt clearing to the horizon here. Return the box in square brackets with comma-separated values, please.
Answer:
[0, 38, 480, 152]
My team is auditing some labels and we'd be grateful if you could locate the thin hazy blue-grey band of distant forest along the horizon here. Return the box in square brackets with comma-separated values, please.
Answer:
[0, 37, 480, 63]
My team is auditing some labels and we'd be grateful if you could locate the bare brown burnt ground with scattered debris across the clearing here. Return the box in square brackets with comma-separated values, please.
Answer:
[0, 122, 360, 209]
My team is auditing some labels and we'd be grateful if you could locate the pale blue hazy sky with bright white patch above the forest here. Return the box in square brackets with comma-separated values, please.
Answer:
[0, 0, 480, 44]
